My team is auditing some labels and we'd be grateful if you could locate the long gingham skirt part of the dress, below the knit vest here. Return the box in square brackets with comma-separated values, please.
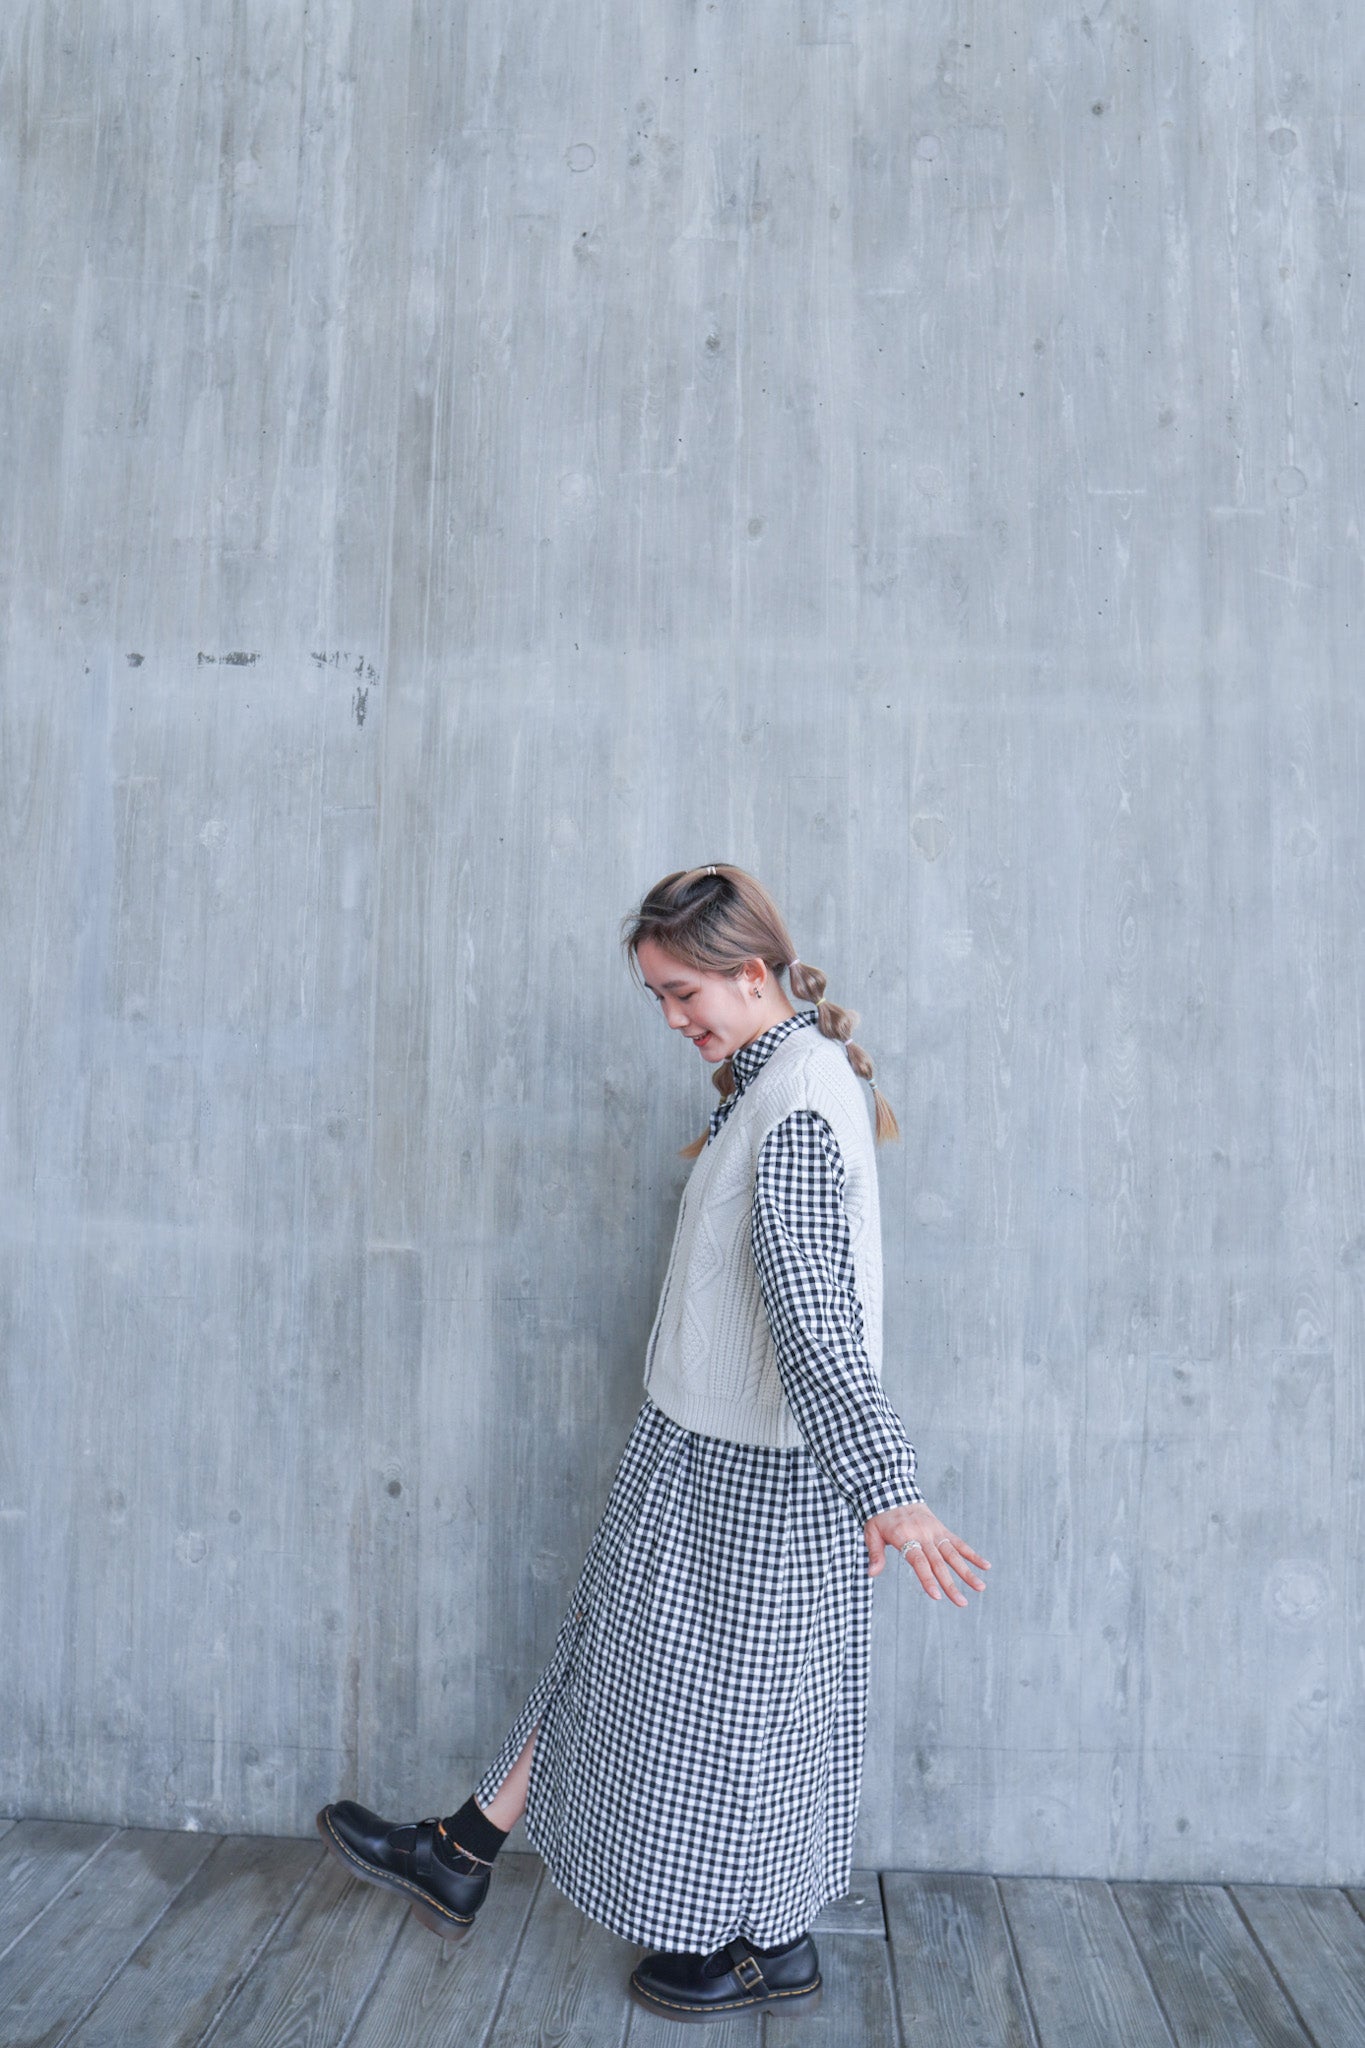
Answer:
[475, 1397, 874, 1954]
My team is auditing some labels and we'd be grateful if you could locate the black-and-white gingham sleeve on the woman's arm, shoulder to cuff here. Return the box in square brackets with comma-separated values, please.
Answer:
[749, 1110, 923, 1522]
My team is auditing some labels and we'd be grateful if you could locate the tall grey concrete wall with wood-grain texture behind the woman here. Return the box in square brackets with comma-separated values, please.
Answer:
[0, 0, 1365, 1882]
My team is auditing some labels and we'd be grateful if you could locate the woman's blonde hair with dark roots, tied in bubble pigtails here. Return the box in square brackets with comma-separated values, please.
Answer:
[622, 860, 900, 1159]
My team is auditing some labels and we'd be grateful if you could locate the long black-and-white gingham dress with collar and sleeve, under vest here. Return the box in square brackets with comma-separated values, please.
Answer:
[475, 1010, 921, 1954]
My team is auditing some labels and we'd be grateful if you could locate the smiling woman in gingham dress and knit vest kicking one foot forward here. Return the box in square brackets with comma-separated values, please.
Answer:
[317, 864, 988, 2019]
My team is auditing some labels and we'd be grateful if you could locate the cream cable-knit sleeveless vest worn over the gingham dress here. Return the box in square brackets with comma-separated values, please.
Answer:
[645, 1026, 882, 1448]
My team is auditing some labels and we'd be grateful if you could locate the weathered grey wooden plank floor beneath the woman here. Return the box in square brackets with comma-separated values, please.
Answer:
[0, 1819, 1365, 2048]
